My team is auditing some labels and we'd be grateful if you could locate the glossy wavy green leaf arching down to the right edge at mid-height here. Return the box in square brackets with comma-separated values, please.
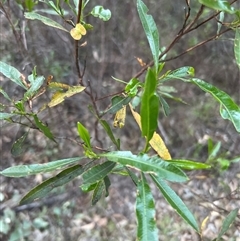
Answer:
[190, 78, 240, 132]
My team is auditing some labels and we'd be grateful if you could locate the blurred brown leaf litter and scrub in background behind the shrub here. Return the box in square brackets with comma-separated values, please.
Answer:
[0, 0, 240, 241]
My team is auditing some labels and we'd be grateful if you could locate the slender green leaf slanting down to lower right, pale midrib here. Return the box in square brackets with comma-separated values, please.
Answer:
[151, 175, 199, 232]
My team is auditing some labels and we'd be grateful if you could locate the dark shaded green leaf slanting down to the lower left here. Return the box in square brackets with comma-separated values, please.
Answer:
[20, 165, 88, 205]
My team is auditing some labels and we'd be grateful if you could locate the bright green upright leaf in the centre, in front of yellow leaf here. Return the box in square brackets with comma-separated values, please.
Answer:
[140, 68, 159, 143]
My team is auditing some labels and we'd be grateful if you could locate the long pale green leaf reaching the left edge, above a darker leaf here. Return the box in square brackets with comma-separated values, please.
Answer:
[0, 157, 84, 177]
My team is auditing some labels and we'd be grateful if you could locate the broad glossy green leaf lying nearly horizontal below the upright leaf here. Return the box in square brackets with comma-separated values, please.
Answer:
[100, 151, 188, 182]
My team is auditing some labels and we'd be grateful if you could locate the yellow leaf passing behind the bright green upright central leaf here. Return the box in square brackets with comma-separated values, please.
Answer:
[129, 105, 172, 160]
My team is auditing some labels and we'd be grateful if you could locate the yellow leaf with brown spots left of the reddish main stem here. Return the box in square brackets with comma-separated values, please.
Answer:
[48, 86, 85, 108]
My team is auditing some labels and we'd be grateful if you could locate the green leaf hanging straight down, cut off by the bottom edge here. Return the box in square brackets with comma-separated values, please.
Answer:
[136, 173, 158, 241]
